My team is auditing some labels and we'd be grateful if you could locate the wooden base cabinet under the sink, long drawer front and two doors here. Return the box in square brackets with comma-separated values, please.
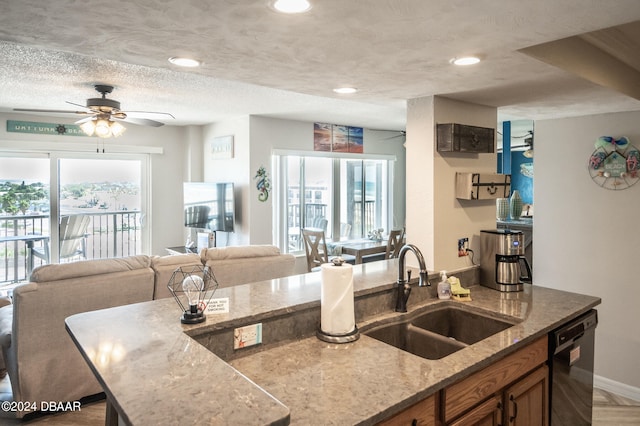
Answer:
[441, 337, 549, 426]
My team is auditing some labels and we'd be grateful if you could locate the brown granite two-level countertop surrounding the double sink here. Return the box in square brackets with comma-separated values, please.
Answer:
[67, 260, 600, 425]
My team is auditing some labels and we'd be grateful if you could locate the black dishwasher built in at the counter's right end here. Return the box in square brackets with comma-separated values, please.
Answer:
[549, 309, 598, 426]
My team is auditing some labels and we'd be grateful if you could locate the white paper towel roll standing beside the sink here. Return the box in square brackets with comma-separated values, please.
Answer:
[320, 263, 356, 336]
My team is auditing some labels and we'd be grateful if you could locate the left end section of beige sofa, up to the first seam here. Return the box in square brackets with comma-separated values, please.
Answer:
[0, 256, 154, 417]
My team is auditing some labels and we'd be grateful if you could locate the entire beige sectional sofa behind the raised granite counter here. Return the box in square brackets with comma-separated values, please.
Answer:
[0, 246, 295, 417]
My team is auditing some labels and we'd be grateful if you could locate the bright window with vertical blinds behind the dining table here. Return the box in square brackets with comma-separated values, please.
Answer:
[274, 153, 393, 253]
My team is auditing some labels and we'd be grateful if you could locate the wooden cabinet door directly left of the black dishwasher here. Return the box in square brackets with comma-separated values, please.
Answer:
[504, 365, 549, 426]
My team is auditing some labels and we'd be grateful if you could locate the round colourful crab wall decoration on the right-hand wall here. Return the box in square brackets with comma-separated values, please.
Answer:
[588, 136, 640, 190]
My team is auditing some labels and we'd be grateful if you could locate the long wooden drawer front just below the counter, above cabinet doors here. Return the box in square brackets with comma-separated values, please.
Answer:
[442, 336, 548, 422]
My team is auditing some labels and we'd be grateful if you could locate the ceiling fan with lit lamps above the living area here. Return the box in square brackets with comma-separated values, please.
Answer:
[13, 84, 175, 127]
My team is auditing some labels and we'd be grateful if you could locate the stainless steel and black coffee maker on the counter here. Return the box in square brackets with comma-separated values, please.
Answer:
[480, 229, 531, 292]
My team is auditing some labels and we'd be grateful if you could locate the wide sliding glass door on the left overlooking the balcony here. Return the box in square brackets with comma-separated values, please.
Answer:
[0, 152, 148, 283]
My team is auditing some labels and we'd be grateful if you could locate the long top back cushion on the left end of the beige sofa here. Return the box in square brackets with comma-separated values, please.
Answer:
[31, 255, 151, 283]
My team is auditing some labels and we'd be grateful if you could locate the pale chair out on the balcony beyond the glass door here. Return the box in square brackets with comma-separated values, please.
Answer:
[31, 214, 91, 263]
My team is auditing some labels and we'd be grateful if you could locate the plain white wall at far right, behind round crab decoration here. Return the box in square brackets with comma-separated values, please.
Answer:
[533, 112, 640, 392]
